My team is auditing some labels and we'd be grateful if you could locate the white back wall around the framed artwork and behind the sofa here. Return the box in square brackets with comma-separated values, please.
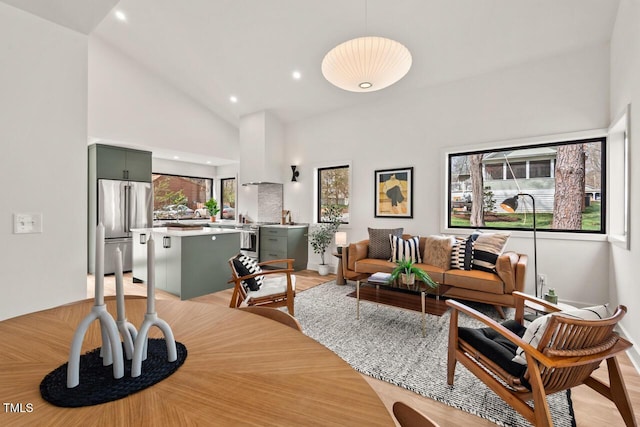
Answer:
[284, 45, 609, 304]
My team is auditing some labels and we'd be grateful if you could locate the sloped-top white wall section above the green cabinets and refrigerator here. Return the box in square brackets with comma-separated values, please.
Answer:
[88, 36, 239, 161]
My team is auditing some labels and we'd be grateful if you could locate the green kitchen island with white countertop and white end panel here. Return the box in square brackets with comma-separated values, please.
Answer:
[132, 227, 240, 300]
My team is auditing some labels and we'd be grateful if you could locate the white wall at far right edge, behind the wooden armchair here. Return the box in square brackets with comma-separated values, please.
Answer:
[609, 0, 640, 366]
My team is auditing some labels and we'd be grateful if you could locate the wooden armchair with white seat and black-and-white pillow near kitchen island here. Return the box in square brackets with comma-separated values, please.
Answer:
[228, 257, 296, 316]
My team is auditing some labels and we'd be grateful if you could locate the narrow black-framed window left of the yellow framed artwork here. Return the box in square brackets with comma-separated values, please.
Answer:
[316, 165, 349, 223]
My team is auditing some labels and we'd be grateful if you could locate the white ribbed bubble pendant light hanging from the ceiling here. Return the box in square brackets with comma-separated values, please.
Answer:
[322, 37, 412, 92]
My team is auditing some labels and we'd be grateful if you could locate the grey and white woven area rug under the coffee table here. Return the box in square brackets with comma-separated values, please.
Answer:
[296, 282, 575, 427]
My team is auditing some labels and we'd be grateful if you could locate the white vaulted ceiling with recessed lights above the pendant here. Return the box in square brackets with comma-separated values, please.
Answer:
[92, 0, 618, 125]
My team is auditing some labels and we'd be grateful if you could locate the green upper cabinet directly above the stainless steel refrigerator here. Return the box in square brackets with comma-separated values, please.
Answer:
[89, 144, 151, 182]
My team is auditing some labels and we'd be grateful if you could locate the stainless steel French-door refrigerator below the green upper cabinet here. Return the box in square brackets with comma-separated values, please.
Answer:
[98, 179, 153, 274]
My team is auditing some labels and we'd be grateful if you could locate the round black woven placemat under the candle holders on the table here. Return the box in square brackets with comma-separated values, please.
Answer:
[40, 338, 187, 408]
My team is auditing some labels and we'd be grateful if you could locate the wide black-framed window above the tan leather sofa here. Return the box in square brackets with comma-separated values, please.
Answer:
[448, 137, 606, 233]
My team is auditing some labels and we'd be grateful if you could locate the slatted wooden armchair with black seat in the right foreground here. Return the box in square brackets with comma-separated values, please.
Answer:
[447, 292, 637, 426]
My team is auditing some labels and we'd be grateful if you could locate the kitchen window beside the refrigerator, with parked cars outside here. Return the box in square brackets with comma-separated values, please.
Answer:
[152, 174, 213, 220]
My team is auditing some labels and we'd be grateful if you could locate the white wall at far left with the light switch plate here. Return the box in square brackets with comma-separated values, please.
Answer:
[0, 3, 88, 320]
